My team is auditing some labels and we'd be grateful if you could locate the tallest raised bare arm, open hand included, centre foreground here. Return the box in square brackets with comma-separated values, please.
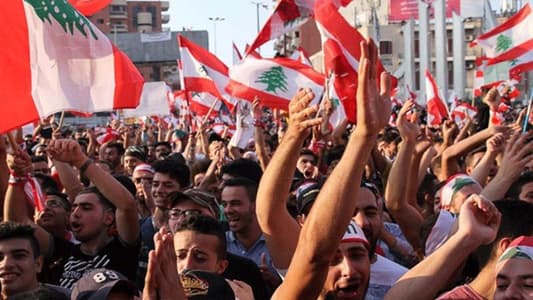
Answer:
[271, 42, 391, 299]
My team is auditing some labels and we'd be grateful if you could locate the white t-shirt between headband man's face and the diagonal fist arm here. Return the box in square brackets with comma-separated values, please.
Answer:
[365, 254, 407, 300]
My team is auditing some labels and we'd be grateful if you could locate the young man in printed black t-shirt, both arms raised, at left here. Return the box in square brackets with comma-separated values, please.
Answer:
[4, 140, 139, 288]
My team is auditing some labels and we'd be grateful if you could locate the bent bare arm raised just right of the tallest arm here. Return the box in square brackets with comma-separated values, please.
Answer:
[385, 100, 424, 250]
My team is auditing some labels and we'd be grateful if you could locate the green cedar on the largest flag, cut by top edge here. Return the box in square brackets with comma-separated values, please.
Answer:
[25, 0, 98, 40]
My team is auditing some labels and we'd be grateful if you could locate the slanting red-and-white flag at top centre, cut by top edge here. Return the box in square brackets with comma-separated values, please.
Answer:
[245, 0, 315, 56]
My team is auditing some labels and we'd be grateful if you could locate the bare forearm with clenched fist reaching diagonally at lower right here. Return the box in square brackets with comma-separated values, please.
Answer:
[385, 195, 501, 300]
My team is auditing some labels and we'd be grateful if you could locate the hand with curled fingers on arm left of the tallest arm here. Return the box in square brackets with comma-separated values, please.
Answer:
[287, 89, 322, 137]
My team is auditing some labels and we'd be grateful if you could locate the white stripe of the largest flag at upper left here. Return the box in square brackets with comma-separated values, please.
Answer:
[24, 2, 115, 116]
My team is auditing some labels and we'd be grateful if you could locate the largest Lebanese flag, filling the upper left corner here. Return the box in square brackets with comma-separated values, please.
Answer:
[0, 0, 143, 132]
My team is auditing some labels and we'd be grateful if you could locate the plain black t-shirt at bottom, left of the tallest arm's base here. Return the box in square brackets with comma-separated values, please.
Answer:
[222, 252, 271, 300]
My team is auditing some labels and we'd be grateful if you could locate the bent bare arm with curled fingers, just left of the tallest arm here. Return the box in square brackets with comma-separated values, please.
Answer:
[256, 89, 320, 269]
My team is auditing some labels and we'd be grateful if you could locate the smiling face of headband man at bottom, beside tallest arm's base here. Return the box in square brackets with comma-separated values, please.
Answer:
[322, 242, 370, 300]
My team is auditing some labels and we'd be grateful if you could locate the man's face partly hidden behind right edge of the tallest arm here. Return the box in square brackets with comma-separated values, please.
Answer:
[353, 187, 383, 255]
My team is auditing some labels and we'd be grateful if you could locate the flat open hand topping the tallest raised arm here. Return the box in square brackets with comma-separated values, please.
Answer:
[354, 41, 392, 136]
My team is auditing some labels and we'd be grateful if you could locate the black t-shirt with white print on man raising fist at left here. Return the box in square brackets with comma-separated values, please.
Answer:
[59, 237, 140, 289]
